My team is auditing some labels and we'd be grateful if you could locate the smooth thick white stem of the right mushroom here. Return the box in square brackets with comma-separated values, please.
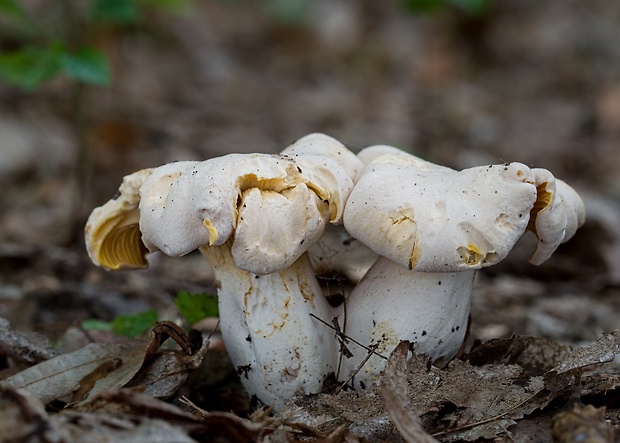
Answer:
[339, 257, 475, 389]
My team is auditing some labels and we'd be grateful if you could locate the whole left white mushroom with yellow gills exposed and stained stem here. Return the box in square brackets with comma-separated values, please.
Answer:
[86, 134, 362, 409]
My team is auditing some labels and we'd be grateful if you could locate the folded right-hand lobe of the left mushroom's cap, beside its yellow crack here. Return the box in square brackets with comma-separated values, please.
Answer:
[232, 134, 363, 274]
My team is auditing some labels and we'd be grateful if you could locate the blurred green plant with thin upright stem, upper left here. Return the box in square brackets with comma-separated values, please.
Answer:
[0, 0, 189, 245]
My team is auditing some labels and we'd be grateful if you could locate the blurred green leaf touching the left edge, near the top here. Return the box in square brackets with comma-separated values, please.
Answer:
[0, 45, 61, 91]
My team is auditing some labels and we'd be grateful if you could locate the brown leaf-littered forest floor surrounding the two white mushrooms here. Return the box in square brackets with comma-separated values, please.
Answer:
[0, 0, 620, 442]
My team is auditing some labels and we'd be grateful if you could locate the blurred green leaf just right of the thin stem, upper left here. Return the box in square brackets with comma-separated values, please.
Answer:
[61, 47, 110, 86]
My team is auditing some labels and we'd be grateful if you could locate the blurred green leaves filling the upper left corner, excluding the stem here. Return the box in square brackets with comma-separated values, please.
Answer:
[0, 0, 187, 91]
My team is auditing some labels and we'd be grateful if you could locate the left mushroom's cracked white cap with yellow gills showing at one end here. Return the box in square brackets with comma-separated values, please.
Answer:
[87, 134, 362, 274]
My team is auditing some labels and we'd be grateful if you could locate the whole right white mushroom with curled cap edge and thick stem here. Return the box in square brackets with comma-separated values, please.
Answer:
[340, 146, 585, 387]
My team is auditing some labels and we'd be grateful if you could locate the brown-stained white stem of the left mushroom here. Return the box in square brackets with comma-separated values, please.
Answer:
[200, 241, 336, 410]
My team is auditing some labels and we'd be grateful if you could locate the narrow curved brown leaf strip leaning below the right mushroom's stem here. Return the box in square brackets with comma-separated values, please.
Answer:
[380, 341, 438, 443]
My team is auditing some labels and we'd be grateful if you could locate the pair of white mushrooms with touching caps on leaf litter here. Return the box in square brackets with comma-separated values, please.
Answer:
[85, 134, 585, 409]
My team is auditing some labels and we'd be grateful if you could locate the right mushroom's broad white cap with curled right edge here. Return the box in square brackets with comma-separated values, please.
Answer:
[344, 146, 582, 272]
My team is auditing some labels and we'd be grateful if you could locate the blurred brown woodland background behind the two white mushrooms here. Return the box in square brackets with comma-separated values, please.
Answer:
[0, 0, 620, 366]
